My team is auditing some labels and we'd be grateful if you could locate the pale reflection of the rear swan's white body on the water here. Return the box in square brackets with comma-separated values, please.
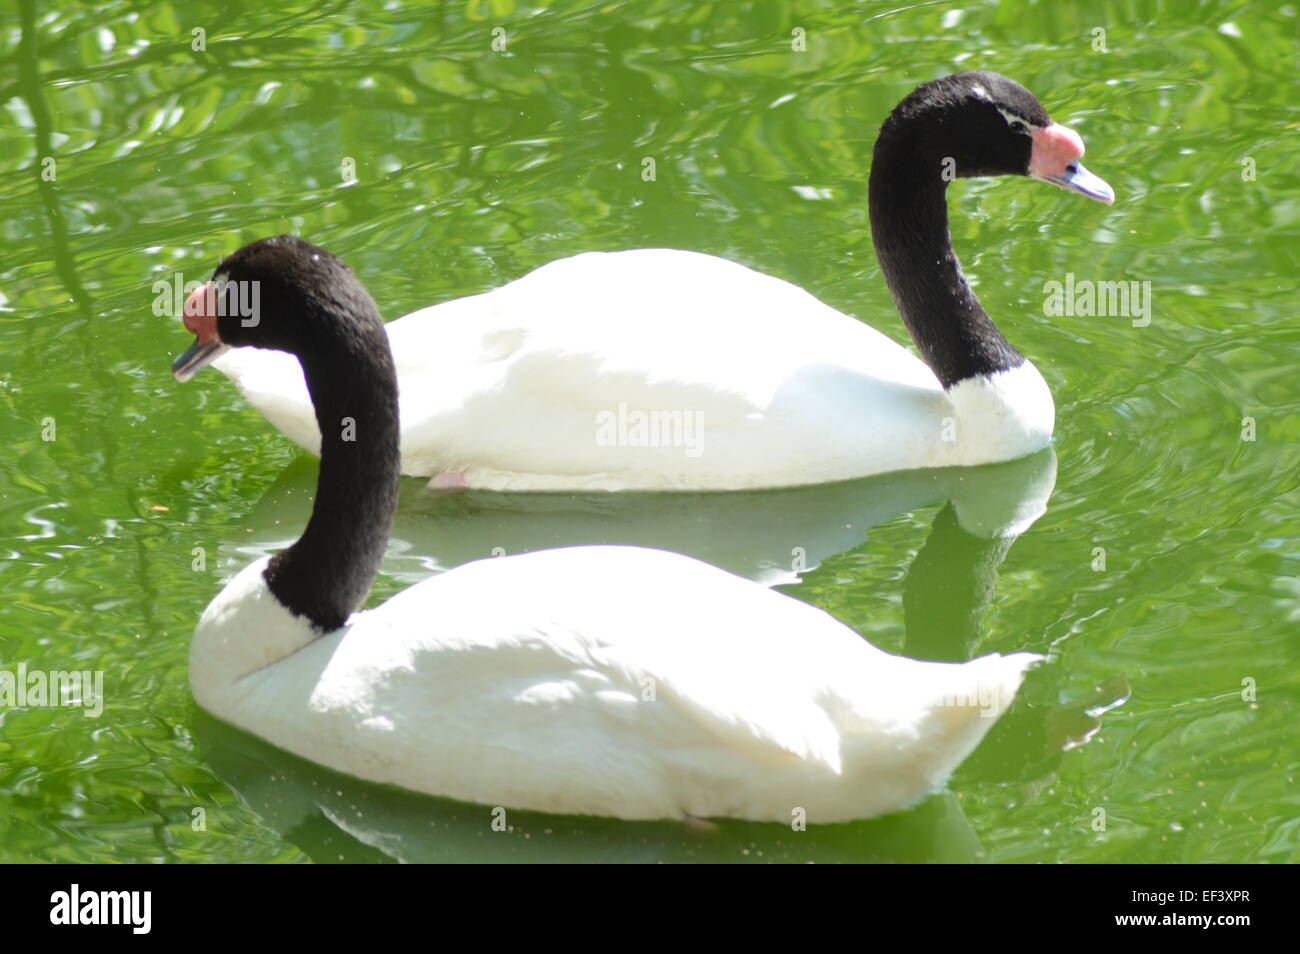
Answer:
[218, 447, 1056, 586]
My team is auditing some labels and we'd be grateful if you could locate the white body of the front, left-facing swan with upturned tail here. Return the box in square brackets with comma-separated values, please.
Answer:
[190, 547, 1037, 823]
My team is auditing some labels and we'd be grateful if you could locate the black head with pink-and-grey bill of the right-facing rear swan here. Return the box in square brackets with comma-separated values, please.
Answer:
[872, 70, 1114, 204]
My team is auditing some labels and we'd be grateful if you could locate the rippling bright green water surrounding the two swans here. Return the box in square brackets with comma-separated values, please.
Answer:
[0, 0, 1300, 862]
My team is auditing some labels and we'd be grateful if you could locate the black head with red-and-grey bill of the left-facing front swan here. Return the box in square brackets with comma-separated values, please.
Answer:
[172, 235, 384, 381]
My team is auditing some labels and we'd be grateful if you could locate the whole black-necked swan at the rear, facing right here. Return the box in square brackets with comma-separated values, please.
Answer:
[183, 73, 1113, 491]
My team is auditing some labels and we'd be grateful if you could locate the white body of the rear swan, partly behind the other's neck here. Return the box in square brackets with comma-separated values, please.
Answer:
[215, 248, 1054, 490]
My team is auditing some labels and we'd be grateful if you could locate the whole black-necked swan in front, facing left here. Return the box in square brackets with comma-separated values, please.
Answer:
[173, 235, 1039, 823]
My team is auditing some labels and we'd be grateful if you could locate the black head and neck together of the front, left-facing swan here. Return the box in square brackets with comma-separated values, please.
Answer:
[172, 235, 400, 633]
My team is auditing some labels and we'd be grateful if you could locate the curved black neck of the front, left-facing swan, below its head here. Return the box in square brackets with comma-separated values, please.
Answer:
[265, 298, 400, 633]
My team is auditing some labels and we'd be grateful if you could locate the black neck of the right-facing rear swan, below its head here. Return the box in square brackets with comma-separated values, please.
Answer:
[868, 132, 1024, 387]
